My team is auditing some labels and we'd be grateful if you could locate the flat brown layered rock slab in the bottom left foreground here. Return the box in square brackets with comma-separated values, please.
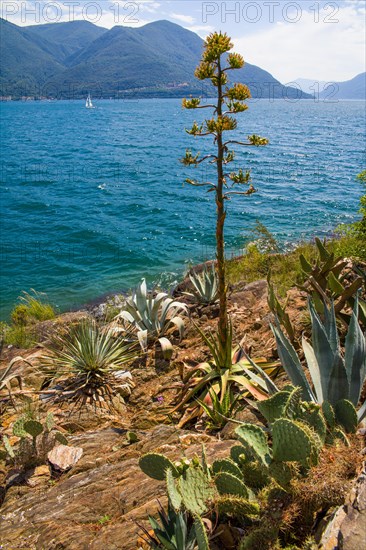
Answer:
[0, 425, 233, 550]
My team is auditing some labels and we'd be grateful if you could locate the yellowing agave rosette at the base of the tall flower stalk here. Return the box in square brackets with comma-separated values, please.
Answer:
[174, 323, 280, 425]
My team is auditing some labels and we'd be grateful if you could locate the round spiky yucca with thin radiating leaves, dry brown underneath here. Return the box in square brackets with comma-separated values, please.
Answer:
[43, 319, 137, 406]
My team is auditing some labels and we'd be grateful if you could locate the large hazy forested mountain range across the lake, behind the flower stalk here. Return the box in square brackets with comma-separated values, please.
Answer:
[0, 19, 311, 99]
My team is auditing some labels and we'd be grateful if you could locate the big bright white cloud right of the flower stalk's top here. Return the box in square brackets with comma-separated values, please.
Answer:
[233, 2, 366, 83]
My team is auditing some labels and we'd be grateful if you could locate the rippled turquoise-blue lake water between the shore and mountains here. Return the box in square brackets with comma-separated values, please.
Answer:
[0, 99, 365, 318]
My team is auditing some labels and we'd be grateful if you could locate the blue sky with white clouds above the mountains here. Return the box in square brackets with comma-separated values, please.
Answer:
[0, 0, 366, 84]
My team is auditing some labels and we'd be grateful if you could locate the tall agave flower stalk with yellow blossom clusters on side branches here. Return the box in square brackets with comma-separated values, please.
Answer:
[182, 32, 268, 362]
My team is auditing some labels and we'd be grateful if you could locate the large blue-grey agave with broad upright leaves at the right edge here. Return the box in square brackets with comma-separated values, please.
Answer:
[248, 296, 366, 431]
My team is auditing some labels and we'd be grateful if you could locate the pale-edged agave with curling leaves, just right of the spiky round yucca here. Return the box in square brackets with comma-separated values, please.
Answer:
[117, 279, 188, 359]
